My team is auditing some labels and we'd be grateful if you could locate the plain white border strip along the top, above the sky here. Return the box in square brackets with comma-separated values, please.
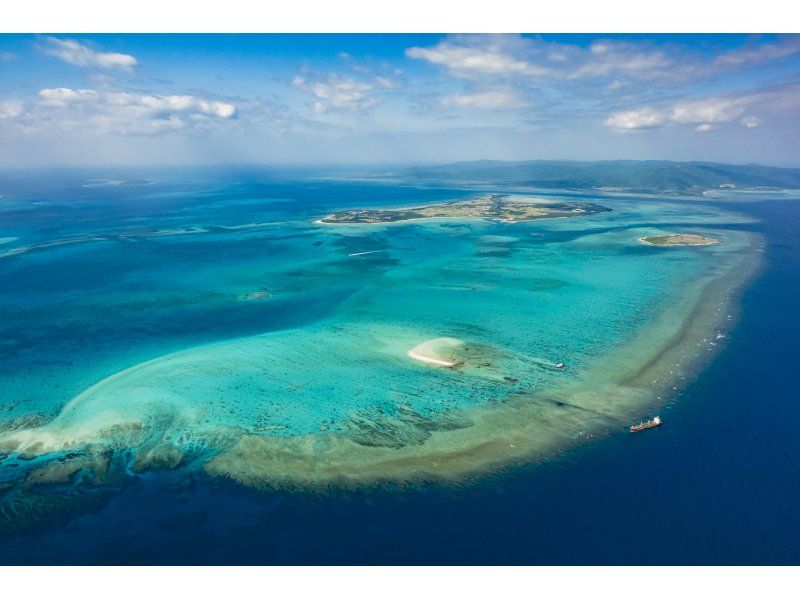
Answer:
[0, 0, 800, 33]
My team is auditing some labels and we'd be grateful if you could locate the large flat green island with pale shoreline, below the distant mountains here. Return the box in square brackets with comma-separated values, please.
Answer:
[320, 194, 611, 224]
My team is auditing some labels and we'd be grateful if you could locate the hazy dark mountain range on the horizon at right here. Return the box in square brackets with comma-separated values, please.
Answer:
[400, 160, 800, 195]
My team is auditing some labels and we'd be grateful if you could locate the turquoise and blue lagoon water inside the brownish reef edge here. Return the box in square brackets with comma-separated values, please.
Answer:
[0, 173, 756, 492]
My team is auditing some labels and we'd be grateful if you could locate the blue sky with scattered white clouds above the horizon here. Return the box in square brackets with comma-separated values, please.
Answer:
[0, 34, 800, 169]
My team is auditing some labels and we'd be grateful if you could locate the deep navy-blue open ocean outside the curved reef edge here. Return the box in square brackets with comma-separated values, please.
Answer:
[0, 172, 800, 564]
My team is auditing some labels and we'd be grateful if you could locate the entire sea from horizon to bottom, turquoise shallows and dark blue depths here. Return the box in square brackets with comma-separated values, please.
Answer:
[0, 173, 800, 564]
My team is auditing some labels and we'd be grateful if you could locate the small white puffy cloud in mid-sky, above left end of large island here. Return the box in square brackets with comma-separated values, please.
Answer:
[292, 74, 395, 114]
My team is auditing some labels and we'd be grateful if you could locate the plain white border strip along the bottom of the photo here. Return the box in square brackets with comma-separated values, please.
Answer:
[0, 567, 800, 598]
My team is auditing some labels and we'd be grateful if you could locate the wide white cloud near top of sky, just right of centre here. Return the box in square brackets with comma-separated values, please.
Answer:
[406, 35, 549, 77]
